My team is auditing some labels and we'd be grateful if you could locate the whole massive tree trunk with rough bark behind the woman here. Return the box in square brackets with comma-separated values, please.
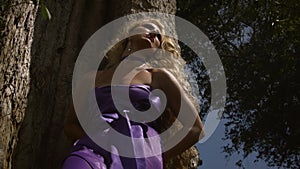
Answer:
[0, 0, 199, 169]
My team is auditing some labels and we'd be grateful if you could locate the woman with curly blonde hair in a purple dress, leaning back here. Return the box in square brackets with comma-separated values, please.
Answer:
[63, 20, 204, 169]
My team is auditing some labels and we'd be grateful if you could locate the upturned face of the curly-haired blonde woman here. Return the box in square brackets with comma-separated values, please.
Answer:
[129, 23, 161, 52]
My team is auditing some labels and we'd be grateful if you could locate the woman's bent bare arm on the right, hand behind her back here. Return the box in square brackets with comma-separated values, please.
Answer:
[152, 69, 204, 158]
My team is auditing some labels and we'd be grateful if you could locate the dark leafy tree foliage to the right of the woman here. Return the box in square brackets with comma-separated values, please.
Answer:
[178, 0, 300, 168]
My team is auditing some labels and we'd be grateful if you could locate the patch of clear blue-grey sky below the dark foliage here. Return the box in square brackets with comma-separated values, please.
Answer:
[197, 120, 278, 169]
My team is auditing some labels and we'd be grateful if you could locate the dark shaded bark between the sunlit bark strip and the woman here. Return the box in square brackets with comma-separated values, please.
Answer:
[13, 0, 107, 169]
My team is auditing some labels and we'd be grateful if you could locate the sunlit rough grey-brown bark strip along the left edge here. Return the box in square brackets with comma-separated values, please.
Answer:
[0, 0, 37, 169]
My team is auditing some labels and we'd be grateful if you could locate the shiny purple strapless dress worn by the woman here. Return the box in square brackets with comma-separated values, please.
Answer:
[62, 84, 163, 169]
